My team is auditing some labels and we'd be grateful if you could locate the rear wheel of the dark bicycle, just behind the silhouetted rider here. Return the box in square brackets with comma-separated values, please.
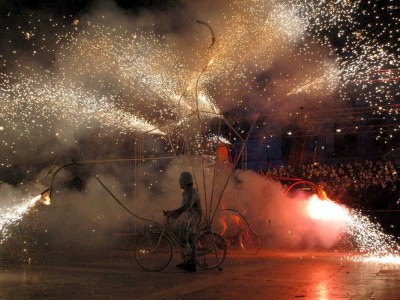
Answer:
[196, 231, 227, 269]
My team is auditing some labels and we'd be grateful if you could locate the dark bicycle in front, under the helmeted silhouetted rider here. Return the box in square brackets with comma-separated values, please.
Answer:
[135, 211, 227, 272]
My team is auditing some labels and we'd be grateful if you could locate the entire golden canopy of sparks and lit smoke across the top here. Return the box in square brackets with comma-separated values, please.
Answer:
[0, 0, 399, 162]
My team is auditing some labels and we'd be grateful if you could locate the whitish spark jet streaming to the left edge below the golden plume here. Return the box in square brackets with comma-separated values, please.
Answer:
[0, 74, 162, 137]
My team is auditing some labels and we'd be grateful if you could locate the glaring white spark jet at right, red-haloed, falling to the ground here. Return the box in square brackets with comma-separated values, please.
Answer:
[308, 195, 400, 264]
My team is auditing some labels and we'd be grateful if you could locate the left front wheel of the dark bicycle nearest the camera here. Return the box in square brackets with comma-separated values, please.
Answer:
[135, 233, 173, 272]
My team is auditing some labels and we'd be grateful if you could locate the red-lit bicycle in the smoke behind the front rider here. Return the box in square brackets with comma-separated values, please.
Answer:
[216, 208, 262, 255]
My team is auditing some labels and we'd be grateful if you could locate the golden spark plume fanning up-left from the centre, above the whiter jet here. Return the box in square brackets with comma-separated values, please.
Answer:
[58, 25, 218, 119]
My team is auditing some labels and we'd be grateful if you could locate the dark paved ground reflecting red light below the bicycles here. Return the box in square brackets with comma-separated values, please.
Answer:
[0, 249, 400, 300]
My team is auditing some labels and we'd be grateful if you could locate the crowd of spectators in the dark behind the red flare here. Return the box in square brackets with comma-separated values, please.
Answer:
[266, 160, 400, 210]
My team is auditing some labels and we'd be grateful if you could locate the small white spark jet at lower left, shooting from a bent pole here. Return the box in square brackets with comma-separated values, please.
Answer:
[0, 195, 41, 245]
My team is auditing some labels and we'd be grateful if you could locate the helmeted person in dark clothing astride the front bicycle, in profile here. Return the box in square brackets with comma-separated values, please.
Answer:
[165, 172, 203, 272]
